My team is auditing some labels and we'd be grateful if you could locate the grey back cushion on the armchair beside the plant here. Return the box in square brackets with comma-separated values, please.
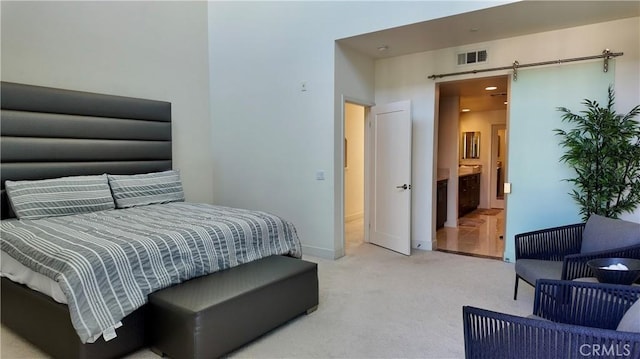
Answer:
[580, 214, 640, 253]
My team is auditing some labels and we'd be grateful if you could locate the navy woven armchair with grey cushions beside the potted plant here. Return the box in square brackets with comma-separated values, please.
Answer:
[513, 215, 640, 300]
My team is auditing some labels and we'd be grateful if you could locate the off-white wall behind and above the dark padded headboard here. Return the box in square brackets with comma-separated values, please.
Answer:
[0, 1, 213, 202]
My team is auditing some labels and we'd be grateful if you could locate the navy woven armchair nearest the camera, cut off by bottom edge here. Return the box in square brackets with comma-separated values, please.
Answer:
[463, 279, 640, 359]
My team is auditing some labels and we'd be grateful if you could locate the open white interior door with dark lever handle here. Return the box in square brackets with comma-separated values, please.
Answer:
[370, 101, 411, 255]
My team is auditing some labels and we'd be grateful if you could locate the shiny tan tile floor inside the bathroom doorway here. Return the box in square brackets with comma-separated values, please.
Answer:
[436, 209, 504, 260]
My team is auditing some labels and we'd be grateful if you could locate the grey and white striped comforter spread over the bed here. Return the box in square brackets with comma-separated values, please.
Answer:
[1, 202, 301, 343]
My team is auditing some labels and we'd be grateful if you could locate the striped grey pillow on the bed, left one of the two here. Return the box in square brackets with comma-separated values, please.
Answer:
[5, 174, 115, 219]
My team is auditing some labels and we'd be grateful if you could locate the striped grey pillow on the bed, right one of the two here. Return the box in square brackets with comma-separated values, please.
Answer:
[108, 170, 184, 208]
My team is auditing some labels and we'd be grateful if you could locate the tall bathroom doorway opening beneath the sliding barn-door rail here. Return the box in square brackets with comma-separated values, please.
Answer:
[434, 75, 509, 260]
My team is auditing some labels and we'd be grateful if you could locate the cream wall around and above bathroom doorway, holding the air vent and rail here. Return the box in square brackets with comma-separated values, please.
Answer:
[375, 18, 640, 260]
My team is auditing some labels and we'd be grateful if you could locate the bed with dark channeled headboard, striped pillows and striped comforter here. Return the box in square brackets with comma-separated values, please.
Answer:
[0, 82, 317, 358]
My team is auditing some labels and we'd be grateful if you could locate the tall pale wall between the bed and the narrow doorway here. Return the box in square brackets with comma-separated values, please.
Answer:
[209, 1, 500, 258]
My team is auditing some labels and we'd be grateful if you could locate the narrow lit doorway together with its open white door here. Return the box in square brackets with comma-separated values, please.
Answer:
[343, 100, 412, 255]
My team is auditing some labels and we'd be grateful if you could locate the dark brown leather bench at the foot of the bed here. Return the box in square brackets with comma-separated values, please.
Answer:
[147, 256, 318, 359]
